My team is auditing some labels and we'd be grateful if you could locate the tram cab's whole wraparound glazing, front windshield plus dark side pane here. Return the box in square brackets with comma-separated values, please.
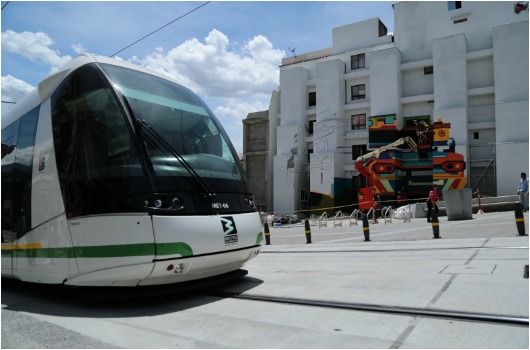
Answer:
[52, 64, 248, 217]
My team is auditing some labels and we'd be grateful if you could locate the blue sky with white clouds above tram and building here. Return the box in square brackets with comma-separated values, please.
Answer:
[1, 1, 395, 154]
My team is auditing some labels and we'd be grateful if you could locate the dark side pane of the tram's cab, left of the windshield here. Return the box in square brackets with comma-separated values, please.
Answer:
[52, 65, 149, 217]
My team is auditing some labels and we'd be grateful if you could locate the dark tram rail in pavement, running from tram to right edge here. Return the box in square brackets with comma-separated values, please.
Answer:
[207, 292, 529, 327]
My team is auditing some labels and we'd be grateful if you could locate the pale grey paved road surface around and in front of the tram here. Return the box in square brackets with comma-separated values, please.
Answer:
[1, 213, 529, 349]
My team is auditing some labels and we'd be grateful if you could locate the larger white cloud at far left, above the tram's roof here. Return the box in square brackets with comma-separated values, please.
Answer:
[2, 30, 72, 71]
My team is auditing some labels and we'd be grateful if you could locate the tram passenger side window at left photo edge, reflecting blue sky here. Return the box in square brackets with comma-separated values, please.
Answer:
[2, 107, 39, 242]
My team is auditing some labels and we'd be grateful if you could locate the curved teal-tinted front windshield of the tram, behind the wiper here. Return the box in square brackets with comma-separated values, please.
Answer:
[102, 65, 244, 185]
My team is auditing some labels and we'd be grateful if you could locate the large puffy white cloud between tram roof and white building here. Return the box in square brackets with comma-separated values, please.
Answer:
[129, 29, 285, 153]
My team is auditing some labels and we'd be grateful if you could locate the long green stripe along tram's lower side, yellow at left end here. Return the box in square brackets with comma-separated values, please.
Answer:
[2, 242, 193, 259]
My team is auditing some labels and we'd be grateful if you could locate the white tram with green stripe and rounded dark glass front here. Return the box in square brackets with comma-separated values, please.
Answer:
[2, 54, 264, 287]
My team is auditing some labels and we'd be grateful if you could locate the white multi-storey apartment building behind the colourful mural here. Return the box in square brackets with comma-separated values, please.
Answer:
[267, 1, 529, 212]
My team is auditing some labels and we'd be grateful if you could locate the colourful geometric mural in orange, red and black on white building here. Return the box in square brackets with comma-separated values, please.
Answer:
[355, 115, 467, 210]
